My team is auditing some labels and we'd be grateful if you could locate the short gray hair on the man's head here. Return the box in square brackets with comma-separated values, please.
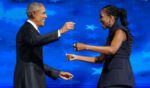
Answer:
[26, 2, 43, 18]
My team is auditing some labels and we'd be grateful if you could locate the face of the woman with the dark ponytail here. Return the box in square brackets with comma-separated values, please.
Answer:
[100, 10, 110, 29]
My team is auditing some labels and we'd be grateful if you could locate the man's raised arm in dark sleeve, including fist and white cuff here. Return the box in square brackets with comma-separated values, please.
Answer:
[25, 22, 75, 46]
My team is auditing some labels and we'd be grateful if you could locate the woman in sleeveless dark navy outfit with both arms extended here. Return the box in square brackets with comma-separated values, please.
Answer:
[67, 5, 134, 88]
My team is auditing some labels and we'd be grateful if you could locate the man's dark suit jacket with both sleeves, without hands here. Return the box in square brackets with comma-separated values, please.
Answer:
[14, 22, 60, 88]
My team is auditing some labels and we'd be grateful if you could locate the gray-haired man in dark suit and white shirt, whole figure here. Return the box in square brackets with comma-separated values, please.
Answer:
[14, 2, 74, 88]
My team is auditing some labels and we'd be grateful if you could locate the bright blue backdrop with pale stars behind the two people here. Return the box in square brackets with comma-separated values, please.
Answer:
[0, 0, 150, 88]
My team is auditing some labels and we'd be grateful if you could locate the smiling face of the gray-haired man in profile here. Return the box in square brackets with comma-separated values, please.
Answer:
[34, 6, 47, 27]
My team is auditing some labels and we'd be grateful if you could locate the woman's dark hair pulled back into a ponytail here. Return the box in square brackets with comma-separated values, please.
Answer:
[102, 5, 128, 27]
